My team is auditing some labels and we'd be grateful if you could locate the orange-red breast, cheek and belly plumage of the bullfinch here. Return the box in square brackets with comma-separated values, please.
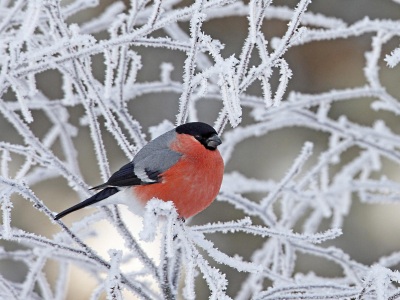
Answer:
[133, 134, 224, 218]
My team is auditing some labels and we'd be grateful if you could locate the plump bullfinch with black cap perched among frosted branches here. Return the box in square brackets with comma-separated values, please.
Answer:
[54, 122, 224, 220]
